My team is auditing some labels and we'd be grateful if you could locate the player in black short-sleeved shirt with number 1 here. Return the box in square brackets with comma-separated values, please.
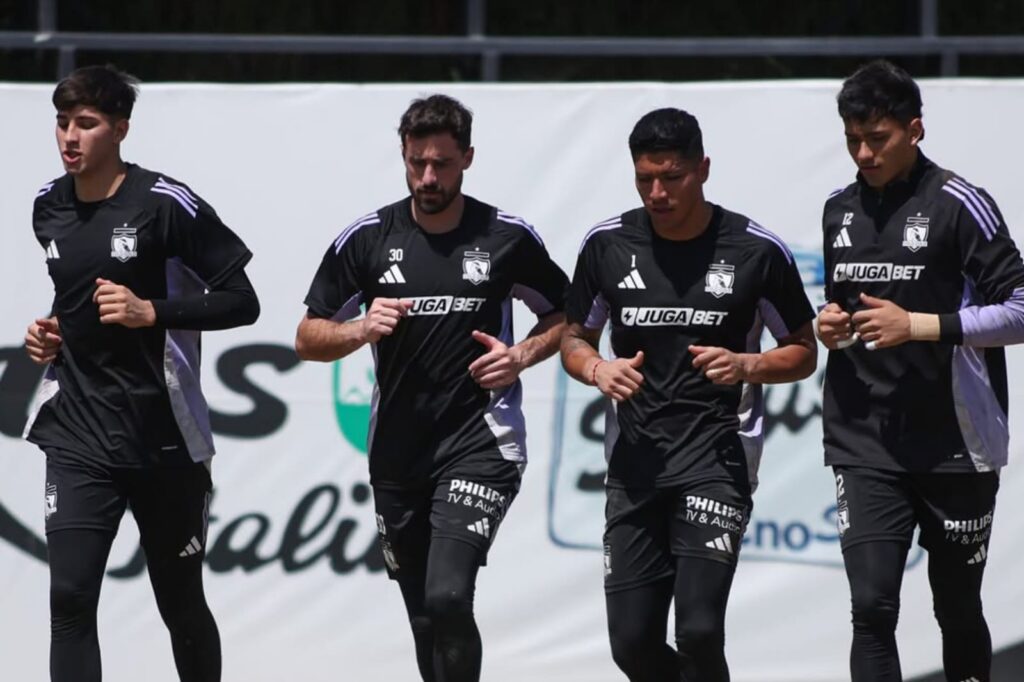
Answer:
[561, 109, 816, 682]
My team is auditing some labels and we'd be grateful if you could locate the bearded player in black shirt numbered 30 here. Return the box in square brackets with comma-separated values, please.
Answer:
[296, 95, 568, 682]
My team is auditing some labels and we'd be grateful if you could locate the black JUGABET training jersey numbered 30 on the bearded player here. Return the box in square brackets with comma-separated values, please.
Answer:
[305, 197, 567, 487]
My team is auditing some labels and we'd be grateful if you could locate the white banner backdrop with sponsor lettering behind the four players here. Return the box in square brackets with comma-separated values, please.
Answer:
[0, 81, 1024, 682]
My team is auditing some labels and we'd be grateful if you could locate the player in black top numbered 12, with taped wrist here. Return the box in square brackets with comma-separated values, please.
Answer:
[817, 61, 1024, 682]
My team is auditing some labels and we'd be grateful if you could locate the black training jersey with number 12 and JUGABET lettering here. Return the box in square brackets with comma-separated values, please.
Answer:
[822, 155, 1024, 472]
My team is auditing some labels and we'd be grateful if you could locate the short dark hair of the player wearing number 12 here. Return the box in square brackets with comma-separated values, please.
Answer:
[836, 59, 922, 125]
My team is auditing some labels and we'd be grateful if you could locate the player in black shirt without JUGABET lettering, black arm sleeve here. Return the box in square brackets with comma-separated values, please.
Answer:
[26, 67, 259, 682]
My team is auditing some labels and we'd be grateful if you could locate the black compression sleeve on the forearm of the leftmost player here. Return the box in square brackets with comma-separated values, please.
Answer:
[152, 269, 259, 332]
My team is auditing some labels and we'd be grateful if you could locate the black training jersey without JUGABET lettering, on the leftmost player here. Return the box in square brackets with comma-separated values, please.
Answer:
[26, 164, 252, 467]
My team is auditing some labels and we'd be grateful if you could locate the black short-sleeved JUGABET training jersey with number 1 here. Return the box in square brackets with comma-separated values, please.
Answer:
[566, 206, 814, 487]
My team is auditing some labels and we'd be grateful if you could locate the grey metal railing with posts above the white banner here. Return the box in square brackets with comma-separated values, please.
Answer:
[8, 0, 1024, 82]
